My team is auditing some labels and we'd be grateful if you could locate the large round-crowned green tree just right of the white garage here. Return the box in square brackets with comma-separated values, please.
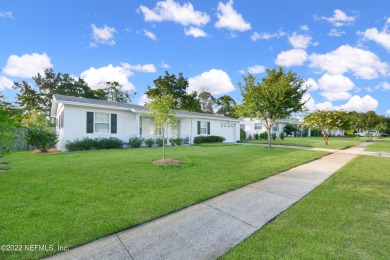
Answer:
[239, 67, 307, 148]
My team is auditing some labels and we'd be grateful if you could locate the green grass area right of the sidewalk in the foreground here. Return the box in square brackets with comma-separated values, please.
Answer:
[222, 156, 390, 259]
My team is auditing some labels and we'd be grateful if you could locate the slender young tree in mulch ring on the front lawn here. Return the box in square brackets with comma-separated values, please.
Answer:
[146, 95, 176, 164]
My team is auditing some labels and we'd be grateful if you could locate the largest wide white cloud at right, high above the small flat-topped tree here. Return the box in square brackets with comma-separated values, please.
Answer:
[309, 45, 389, 79]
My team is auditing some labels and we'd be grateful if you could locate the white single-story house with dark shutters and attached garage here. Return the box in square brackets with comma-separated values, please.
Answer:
[51, 95, 240, 151]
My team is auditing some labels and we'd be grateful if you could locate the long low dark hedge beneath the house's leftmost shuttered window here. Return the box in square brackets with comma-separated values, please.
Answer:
[65, 137, 123, 151]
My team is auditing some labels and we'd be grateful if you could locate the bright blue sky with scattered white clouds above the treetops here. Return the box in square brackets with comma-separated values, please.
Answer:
[0, 0, 390, 116]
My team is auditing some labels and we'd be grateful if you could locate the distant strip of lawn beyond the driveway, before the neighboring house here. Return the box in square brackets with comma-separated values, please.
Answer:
[246, 136, 369, 149]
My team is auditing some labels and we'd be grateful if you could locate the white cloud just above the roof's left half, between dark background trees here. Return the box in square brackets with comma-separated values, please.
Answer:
[80, 64, 135, 90]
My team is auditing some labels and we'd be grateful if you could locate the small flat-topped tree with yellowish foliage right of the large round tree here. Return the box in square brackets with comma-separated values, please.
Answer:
[304, 110, 349, 145]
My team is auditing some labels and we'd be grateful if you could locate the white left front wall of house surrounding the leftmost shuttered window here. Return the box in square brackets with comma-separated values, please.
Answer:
[58, 105, 139, 150]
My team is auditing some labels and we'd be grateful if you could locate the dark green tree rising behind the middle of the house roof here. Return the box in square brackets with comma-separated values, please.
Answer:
[145, 71, 201, 112]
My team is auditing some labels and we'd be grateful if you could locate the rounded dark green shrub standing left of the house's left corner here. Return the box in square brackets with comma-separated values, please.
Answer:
[24, 127, 58, 153]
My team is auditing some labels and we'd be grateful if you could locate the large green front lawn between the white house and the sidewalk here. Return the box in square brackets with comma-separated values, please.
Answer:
[0, 144, 326, 259]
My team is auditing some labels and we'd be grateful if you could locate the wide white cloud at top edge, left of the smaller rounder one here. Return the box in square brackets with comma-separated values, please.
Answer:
[138, 0, 210, 26]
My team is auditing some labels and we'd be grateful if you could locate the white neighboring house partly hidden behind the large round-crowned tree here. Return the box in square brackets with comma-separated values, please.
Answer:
[240, 118, 300, 137]
